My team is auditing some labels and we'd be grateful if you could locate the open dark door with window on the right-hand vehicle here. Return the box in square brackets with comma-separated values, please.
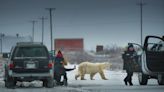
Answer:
[143, 36, 164, 73]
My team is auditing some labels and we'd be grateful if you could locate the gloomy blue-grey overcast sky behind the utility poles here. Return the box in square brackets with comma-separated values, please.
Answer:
[0, 0, 164, 50]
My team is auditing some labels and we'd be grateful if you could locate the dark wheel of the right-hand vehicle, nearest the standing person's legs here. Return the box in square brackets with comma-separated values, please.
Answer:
[138, 73, 148, 85]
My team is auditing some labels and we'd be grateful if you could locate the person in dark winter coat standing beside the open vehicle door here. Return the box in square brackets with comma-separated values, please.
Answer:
[122, 44, 137, 86]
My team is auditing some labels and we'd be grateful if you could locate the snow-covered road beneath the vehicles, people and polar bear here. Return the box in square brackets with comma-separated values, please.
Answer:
[0, 71, 164, 92]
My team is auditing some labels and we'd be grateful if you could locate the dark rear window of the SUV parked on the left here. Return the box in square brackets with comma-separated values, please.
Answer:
[14, 47, 48, 58]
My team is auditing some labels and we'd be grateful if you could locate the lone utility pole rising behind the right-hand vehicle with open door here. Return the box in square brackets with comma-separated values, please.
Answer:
[138, 0, 146, 46]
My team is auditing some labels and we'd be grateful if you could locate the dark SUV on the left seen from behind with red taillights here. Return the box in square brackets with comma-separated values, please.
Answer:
[4, 42, 54, 88]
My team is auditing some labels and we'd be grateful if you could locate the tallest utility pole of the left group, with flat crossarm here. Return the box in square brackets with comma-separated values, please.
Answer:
[46, 8, 55, 51]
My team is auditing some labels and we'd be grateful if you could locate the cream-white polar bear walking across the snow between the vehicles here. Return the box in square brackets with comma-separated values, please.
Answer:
[75, 61, 111, 80]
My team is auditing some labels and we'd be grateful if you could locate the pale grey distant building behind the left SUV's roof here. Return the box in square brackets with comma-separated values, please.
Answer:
[0, 34, 32, 53]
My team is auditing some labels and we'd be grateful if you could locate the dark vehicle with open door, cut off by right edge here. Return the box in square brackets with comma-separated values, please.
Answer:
[131, 36, 164, 85]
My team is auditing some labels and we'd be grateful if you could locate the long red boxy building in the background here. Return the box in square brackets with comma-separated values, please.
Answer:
[54, 38, 84, 51]
